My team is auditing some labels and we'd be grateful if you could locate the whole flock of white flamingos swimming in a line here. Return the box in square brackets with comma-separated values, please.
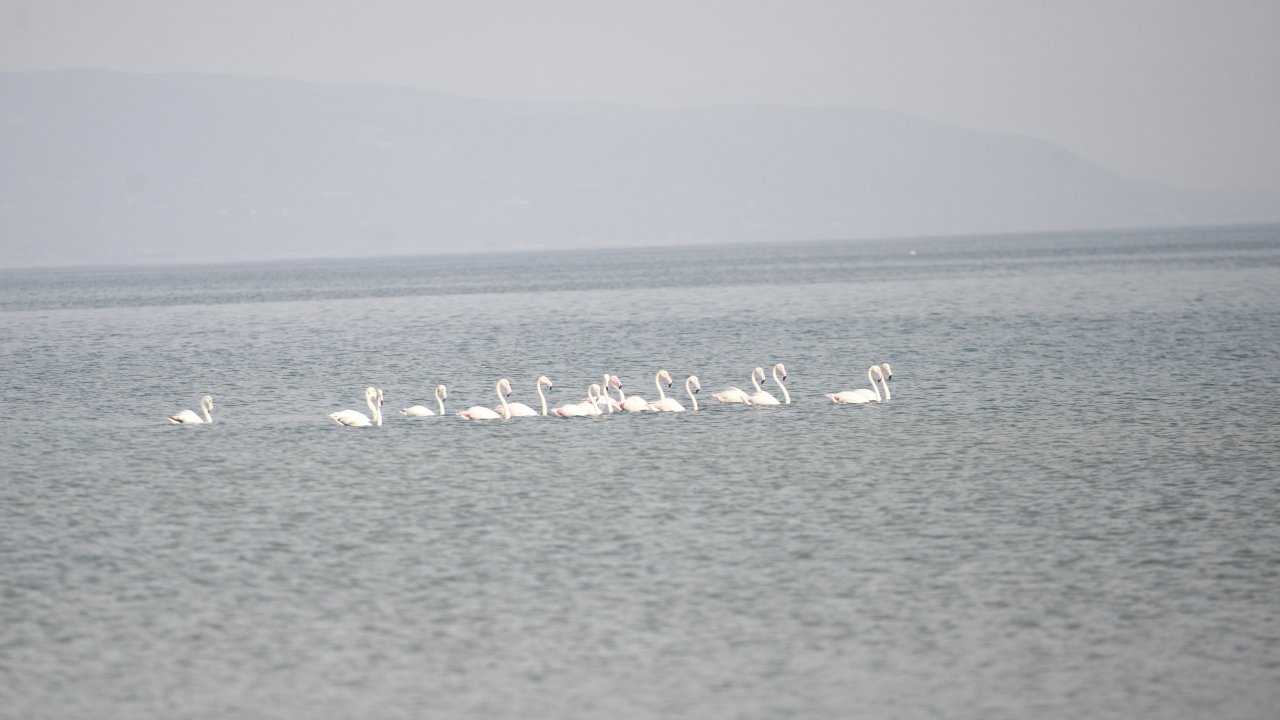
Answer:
[168, 363, 893, 428]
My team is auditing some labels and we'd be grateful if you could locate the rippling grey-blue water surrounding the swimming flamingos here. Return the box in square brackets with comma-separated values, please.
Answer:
[0, 227, 1280, 719]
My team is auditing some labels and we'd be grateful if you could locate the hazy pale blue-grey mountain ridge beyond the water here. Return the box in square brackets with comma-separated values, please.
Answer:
[0, 70, 1280, 266]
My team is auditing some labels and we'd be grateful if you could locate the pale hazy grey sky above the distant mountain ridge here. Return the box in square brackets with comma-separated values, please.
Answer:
[0, 0, 1280, 192]
